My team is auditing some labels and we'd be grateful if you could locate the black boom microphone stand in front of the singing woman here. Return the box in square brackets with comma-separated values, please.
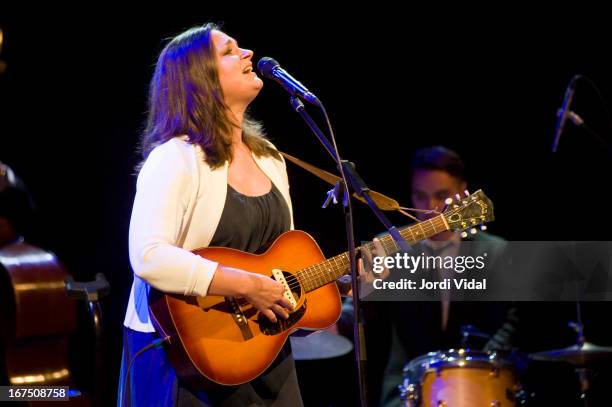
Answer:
[290, 96, 409, 407]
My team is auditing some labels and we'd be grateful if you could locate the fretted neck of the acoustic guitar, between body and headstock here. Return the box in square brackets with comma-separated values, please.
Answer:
[297, 215, 449, 292]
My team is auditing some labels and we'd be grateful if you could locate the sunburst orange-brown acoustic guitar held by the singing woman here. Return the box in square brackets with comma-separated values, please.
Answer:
[149, 190, 494, 388]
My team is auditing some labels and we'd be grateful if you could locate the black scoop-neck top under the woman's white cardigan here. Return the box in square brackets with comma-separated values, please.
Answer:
[210, 183, 291, 253]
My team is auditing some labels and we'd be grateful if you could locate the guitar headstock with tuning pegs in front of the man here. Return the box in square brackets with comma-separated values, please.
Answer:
[442, 189, 495, 237]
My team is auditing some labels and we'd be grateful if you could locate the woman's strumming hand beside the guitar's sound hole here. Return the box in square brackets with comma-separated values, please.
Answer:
[244, 273, 292, 322]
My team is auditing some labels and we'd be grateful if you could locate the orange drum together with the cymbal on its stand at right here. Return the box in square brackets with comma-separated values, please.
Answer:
[399, 323, 612, 407]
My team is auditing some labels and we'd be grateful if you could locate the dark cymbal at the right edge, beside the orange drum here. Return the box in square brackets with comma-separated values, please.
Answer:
[529, 342, 612, 366]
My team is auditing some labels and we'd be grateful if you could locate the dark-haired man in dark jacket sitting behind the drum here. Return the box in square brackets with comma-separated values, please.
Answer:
[376, 146, 518, 407]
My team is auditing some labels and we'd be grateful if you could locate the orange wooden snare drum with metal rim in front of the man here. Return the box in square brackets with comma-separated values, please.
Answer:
[399, 349, 519, 407]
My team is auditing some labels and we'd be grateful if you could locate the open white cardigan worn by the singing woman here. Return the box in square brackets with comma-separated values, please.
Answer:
[123, 137, 293, 332]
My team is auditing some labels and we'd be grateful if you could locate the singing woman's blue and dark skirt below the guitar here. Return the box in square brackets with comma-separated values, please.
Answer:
[117, 328, 303, 407]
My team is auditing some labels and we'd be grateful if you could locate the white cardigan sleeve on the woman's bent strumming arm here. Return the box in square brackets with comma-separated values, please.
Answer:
[129, 142, 218, 296]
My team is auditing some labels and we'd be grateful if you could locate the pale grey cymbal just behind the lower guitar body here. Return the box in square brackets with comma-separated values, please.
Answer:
[289, 331, 353, 360]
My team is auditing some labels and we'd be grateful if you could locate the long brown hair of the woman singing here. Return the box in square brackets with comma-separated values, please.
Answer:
[140, 23, 281, 169]
